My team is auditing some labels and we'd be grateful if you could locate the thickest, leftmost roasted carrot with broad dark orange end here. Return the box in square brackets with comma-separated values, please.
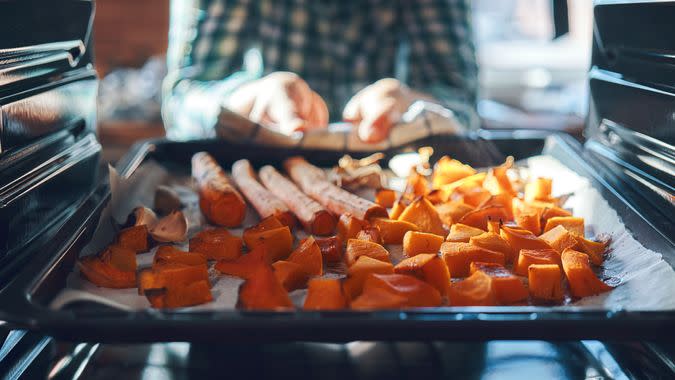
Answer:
[192, 152, 246, 227]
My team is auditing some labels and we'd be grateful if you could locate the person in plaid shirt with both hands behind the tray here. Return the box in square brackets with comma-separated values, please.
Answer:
[162, 0, 477, 143]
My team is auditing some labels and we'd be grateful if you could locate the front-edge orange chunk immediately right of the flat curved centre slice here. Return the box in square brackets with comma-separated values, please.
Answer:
[448, 271, 497, 306]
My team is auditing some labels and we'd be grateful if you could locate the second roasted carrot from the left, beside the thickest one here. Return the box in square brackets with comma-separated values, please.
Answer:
[232, 159, 295, 228]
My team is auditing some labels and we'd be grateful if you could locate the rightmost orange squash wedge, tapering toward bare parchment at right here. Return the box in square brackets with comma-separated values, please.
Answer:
[562, 248, 612, 297]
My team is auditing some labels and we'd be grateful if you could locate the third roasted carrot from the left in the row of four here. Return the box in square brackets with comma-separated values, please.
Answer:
[259, 165, 337, 235]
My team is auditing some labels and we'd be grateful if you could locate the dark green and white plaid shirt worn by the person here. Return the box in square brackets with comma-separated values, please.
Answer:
[163, 0, 477, 139]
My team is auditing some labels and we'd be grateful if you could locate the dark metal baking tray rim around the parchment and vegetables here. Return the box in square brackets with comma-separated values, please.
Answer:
[0, 132, 675, 342]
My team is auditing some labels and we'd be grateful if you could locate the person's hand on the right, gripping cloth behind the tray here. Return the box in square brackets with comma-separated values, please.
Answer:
[342, 78, 428, 143]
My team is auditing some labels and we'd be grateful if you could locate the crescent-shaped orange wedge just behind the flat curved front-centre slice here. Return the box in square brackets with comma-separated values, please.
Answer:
[394, 253, 450, 296]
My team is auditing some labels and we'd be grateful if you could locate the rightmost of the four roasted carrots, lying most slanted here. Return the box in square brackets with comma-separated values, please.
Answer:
[284, 157, 389, 220]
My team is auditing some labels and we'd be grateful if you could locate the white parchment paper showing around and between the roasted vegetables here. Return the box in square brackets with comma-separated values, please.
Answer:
[50, 156, 675, 311]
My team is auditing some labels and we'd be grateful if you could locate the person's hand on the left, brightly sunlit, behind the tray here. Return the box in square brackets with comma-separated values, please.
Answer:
[225, 72, 328, 135]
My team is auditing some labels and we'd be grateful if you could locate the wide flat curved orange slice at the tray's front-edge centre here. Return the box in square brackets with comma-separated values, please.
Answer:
[352, 274, 441, 308]
